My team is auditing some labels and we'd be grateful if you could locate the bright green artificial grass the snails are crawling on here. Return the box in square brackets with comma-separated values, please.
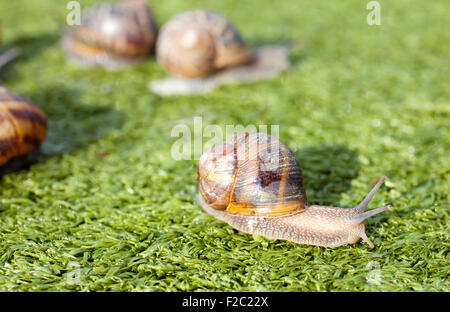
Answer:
[0, 0, 450, 291]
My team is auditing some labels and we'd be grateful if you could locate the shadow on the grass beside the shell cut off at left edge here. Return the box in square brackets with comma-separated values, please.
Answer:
[0, 86, 124, 177]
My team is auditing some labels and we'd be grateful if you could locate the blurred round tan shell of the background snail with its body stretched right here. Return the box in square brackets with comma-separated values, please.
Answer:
[156, 10, 252, 78]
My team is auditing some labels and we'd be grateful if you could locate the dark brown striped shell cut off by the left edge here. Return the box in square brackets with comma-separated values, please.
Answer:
[0, 86, 47, 166]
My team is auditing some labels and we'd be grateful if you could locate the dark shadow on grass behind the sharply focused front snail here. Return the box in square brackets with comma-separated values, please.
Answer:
[296, 144, 361, 206]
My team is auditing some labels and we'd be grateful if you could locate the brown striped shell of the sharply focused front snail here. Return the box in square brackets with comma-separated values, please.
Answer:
[198, 133, 307, 217]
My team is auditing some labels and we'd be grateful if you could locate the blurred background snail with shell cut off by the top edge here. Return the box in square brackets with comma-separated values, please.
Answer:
[62, 0, 157, 69]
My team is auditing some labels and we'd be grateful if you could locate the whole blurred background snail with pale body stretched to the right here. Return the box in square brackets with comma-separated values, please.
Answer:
[150, 9, 293, 96]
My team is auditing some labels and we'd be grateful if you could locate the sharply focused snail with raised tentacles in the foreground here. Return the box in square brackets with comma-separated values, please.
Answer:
[198, 133, 392, 248]
